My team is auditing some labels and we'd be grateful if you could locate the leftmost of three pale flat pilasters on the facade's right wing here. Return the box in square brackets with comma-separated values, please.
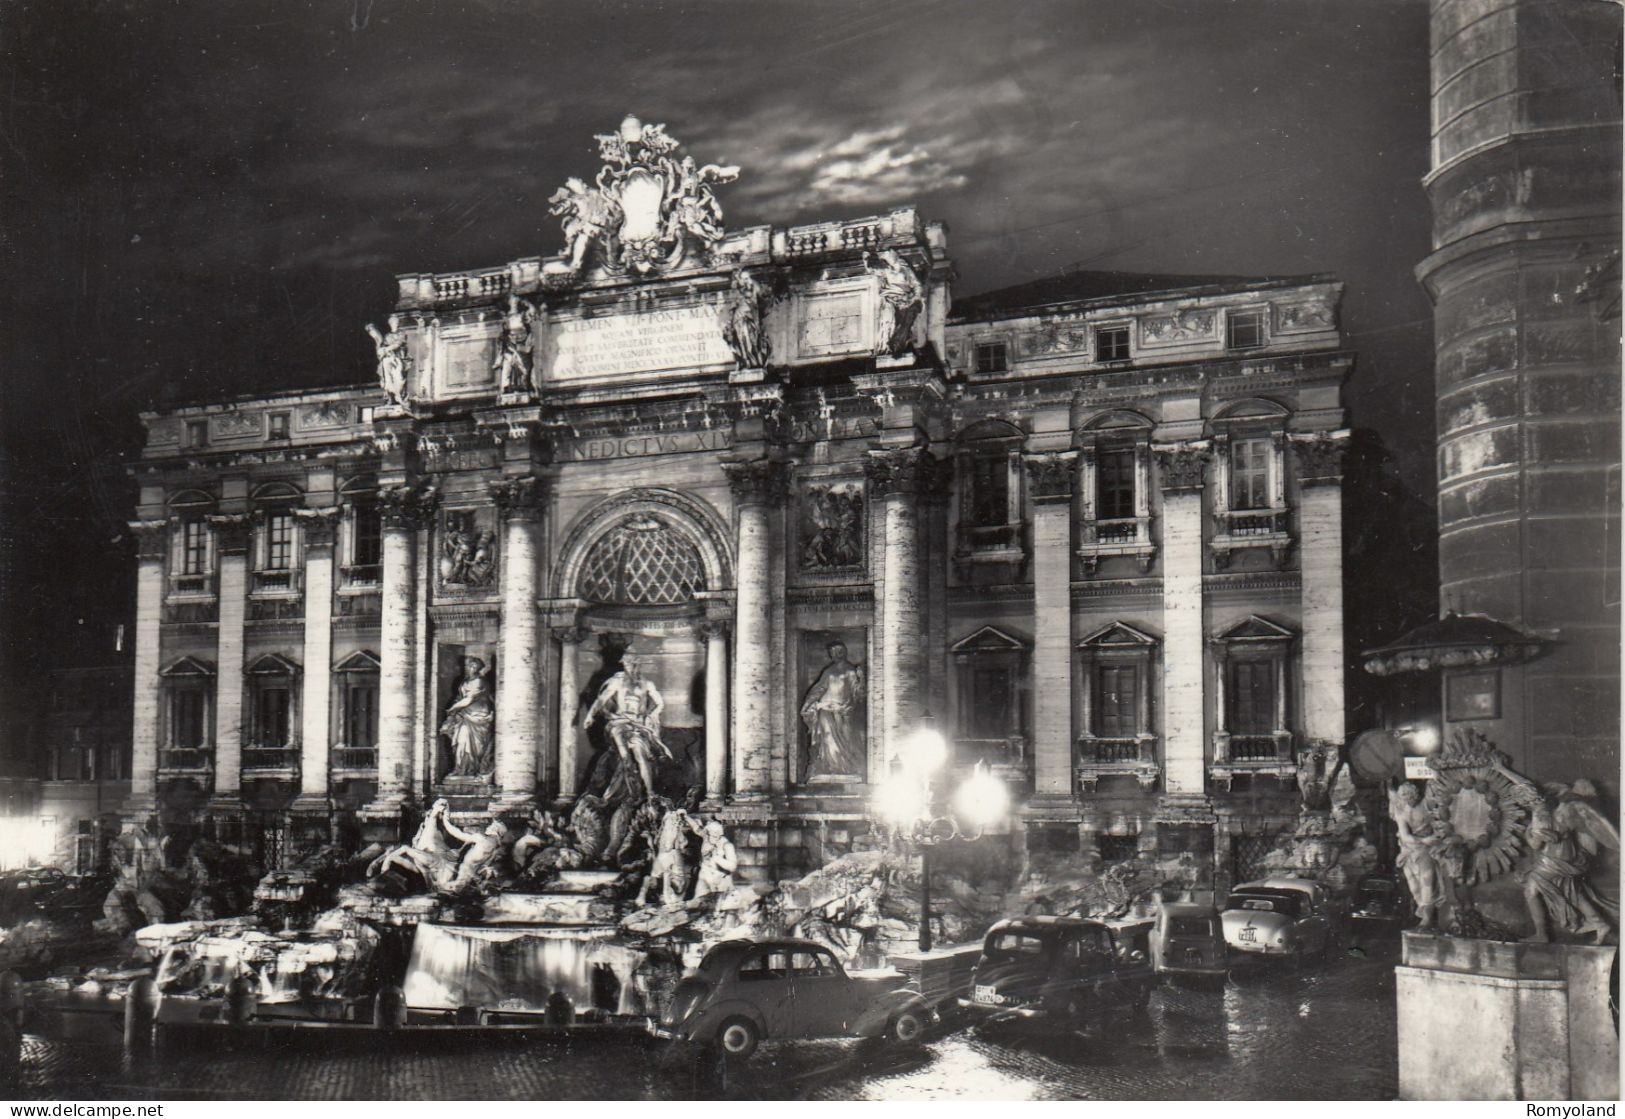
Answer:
[1025, 451, 1087, 796]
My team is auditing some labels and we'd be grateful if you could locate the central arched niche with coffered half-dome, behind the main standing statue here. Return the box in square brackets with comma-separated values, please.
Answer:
[553, 487, 733, 796]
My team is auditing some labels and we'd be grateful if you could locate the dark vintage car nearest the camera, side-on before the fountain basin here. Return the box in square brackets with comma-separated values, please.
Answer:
[655, 939, 933, 1059]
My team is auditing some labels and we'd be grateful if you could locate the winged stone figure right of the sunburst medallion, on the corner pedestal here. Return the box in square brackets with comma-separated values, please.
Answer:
[1523, 780, 1620, 944]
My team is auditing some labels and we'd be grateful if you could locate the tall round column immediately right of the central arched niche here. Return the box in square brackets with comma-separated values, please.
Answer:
[723, 458, 788, 799]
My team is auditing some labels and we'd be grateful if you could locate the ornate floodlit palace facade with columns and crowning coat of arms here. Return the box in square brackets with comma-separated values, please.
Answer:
[130, 119, 1354, 888]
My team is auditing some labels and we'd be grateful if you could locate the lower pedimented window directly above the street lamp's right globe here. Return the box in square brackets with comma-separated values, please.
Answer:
[949, 625, 1030, 778]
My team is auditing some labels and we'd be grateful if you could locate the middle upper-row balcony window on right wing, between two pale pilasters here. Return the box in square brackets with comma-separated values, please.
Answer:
[1077, 413, 1157, 575]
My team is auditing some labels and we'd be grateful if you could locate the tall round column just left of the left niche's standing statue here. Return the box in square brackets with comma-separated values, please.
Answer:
[369, 486, 429, 814]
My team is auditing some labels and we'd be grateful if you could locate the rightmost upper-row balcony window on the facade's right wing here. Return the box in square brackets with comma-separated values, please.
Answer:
[1211, 401, 1292, 568]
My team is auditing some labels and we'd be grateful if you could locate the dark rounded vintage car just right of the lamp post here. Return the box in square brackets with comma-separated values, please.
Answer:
[959, 918, 1157, 1022]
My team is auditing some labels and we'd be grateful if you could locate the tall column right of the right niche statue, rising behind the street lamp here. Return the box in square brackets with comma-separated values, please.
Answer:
[868, 447, 936, 765]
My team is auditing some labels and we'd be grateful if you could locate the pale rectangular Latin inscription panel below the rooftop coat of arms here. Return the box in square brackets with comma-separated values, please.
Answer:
[548, 304, 733, 380]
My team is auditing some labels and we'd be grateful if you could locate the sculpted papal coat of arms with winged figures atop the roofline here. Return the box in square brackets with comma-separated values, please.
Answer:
[548, 117, 739, 276]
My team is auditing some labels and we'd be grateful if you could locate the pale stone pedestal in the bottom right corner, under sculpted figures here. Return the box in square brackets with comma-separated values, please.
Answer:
[1394, 932, 1620, 1100]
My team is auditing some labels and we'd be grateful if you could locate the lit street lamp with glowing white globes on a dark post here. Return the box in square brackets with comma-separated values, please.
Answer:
[874, 713, 1009, 952]
